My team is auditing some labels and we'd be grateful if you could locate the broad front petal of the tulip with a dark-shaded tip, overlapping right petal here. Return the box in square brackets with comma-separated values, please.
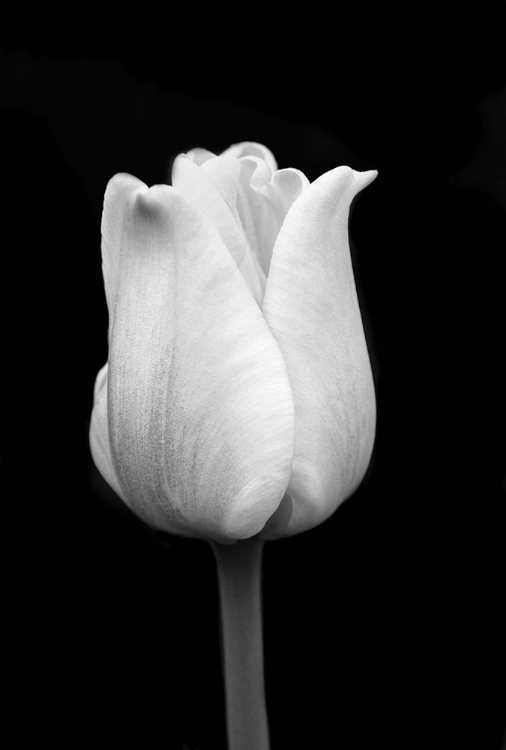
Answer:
[109, 176, 294, 541]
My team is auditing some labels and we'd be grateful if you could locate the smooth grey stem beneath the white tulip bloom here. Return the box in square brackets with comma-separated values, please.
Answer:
[211, 537, 269, 750]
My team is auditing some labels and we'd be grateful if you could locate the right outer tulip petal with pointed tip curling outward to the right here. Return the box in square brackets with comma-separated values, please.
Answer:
[263, 167, 377, 538]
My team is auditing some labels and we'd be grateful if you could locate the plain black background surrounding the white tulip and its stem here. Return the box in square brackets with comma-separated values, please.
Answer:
[0, 11, 506, 750]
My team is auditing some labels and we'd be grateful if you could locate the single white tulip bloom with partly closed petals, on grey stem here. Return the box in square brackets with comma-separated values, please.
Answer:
[90, 142, 376, 750]
